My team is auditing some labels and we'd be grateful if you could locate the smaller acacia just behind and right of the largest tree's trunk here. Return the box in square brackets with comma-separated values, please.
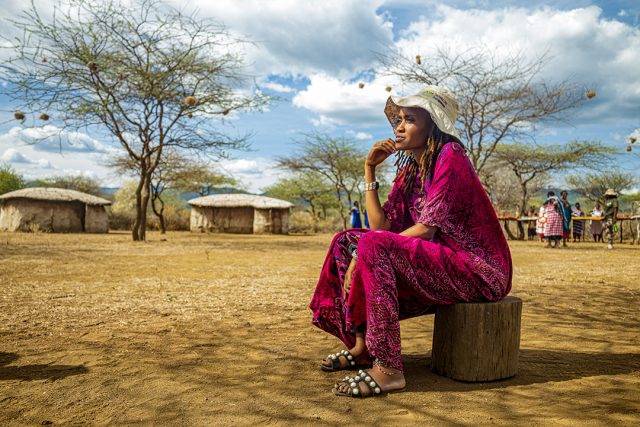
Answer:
[105, 148, 240, 234]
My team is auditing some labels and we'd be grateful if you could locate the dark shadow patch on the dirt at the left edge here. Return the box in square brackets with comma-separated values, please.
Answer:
[0, 352, 89, 381]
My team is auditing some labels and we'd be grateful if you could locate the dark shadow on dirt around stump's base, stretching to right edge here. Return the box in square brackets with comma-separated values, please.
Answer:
[402, 349, 640, 392]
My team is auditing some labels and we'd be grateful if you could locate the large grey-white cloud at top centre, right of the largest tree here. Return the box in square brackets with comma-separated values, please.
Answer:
[190, 0, 393, 78]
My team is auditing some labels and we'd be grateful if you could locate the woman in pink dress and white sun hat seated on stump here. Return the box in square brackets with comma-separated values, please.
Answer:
[310, 86, 512, 397]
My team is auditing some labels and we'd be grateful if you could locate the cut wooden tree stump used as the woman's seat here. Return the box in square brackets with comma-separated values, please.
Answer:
[431, 296, 522, 382]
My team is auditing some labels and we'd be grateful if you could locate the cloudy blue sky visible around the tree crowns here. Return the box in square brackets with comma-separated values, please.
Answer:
[0, 0, 640, 191]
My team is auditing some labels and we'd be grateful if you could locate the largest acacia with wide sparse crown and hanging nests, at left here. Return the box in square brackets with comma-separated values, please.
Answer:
[2, 0, 273, 240]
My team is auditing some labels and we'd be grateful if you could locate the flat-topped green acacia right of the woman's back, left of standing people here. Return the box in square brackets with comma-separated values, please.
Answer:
[492, 140, 618, 239]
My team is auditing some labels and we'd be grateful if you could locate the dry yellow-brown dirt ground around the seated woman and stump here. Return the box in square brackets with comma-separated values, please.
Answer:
[0, 232, 640, 426]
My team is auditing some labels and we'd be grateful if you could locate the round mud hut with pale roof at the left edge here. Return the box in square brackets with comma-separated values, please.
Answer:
[0, 188, 111, 233]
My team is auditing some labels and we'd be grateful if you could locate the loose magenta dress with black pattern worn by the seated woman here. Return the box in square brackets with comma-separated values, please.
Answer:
[310, 143, 512, 369]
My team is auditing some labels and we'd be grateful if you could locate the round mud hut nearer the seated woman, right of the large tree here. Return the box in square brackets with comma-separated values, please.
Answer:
[187, 194, 293, 234]
